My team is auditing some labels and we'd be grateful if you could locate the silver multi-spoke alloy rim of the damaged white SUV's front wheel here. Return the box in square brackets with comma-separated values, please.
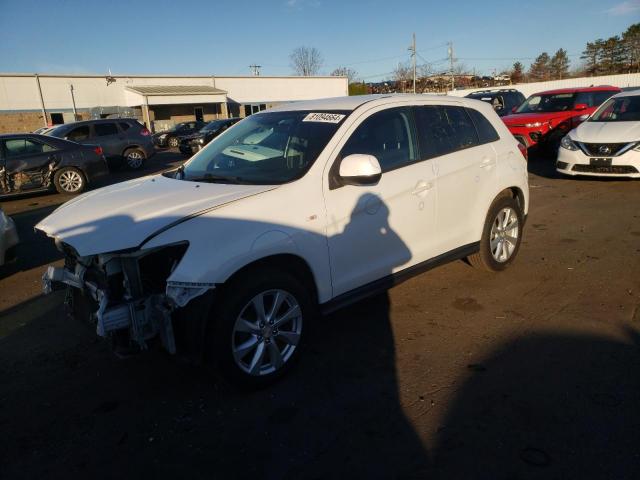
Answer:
[231, 290, 302, 376]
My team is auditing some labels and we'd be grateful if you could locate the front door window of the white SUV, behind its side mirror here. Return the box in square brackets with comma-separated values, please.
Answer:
[341, 108, 417, 172]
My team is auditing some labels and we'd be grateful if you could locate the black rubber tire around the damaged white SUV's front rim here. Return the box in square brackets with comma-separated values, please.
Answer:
[207, 268, 314, 390]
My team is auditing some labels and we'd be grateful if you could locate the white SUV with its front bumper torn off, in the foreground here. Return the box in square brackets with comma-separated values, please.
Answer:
[36, 95, 529, 386]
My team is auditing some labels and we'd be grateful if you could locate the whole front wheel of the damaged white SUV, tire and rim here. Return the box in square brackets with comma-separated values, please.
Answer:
[209, 269, 312, 389]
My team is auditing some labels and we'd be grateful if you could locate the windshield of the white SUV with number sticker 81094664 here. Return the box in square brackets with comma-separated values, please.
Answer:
[175, 111, 349, 185]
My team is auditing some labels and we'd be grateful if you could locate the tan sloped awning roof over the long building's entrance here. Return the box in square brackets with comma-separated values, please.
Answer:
[125, 85, 227, 106]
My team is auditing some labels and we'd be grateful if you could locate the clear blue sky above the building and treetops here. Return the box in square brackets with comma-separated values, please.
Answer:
[0, 0, 640, 81]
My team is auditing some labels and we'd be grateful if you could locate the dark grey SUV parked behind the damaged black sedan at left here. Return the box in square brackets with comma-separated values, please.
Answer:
[45, 118, 155, 170]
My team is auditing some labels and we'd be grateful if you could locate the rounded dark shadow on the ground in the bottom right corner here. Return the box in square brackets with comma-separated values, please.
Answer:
[431, 327, 640, 480]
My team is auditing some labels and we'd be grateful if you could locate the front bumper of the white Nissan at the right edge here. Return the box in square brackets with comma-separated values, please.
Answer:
[556, 147, 640, 178]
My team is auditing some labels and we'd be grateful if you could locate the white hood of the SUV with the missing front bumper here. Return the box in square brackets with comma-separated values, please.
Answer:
[35, 175, 277, 256]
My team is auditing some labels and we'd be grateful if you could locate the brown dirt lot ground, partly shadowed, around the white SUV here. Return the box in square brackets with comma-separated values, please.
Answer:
[0, 152, 640, 479]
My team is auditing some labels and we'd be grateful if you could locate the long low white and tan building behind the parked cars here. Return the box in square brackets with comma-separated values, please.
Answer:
[0, 73, 349, 133]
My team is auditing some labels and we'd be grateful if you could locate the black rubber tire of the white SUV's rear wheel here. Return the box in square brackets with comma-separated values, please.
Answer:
[467, 193, 524, 272]
